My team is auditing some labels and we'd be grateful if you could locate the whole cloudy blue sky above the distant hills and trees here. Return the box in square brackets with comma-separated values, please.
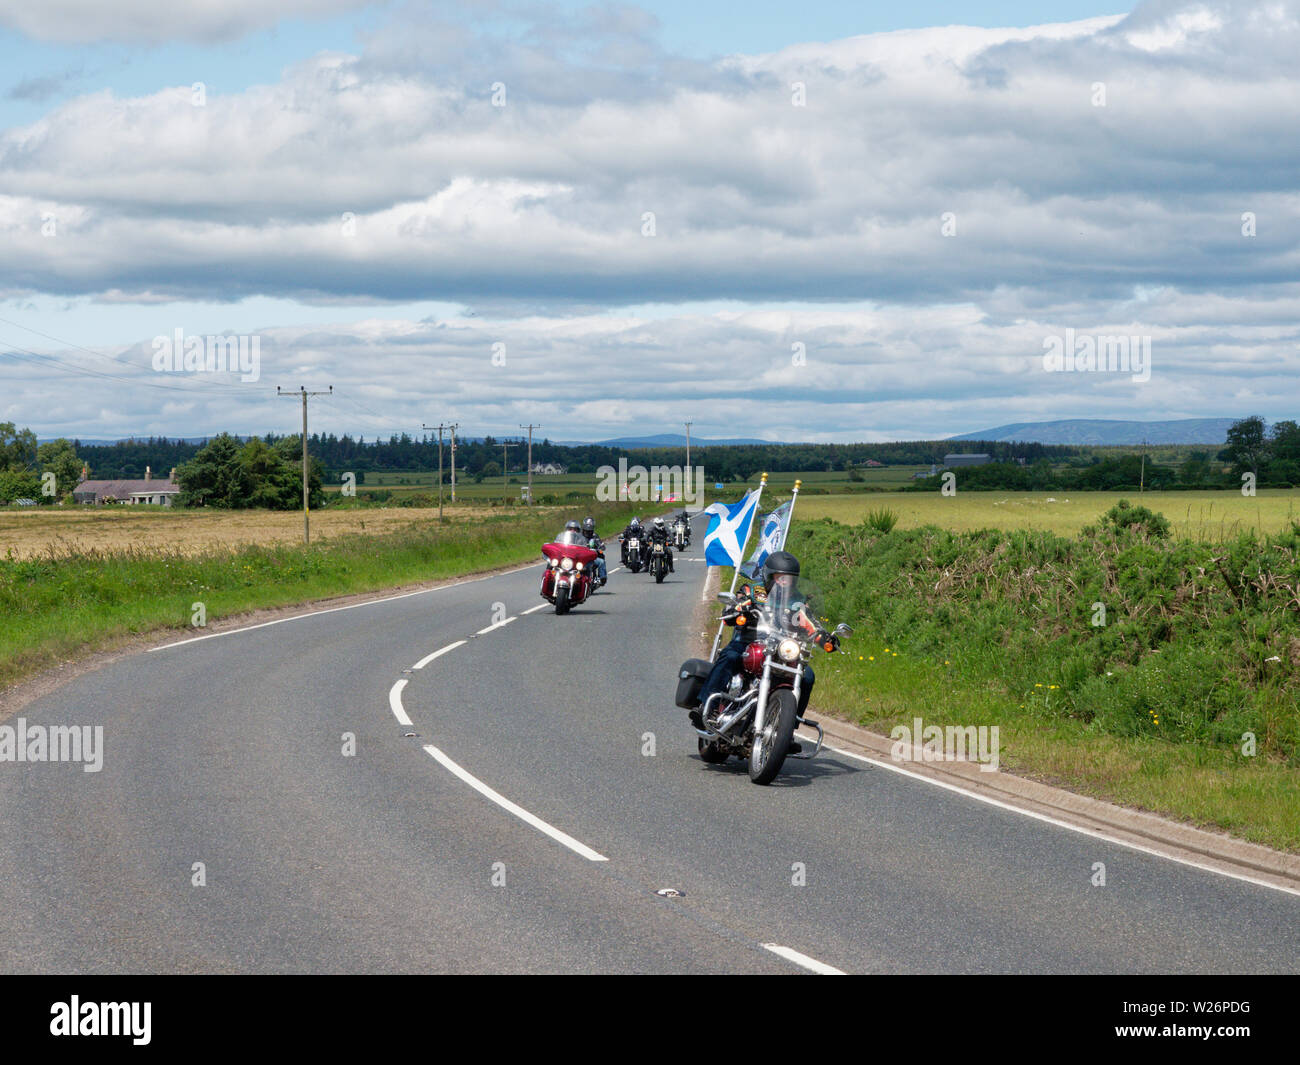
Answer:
[0, 0, 1300, 441]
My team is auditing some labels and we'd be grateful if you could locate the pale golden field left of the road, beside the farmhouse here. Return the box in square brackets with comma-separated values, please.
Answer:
[0, 503, 527, 558]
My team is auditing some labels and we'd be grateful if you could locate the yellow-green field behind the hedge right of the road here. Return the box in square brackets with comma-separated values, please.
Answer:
[796, 489, 1300, 540]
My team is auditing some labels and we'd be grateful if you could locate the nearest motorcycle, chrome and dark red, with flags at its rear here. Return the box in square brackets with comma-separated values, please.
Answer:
[677, 592, 853, 784]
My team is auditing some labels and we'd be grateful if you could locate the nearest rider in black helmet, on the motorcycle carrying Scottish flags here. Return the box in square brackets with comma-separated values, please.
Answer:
[689, 551, 840, 754]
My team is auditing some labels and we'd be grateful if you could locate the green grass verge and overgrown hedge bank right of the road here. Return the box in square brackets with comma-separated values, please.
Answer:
[790, 512, 1300, 852]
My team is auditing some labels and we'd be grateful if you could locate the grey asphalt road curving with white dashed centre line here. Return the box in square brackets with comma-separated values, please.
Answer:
[0, 517, 1300, 973]
